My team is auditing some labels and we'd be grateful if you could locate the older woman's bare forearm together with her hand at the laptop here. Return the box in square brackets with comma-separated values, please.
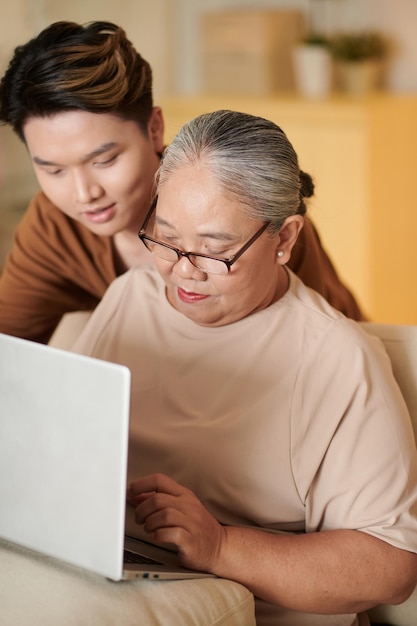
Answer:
[128, 474, 417, 614]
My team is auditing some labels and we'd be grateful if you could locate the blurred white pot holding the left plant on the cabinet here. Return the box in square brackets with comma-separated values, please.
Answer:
[293, 44, 332, 98]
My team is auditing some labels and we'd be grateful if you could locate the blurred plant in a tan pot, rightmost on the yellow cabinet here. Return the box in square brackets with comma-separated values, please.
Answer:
[330, 31, 387, 95]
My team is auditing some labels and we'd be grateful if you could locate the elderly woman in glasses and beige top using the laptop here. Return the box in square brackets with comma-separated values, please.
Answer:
[74, 111, 417, 626]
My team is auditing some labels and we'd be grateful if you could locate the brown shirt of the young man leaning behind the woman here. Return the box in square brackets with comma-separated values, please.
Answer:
[0, 192, 364, 343]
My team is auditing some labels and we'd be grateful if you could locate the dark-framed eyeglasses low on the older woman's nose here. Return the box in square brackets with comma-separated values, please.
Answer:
[138, 198, 269, 275]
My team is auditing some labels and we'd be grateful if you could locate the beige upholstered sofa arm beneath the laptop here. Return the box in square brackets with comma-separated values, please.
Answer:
[0, 541, 255, 626]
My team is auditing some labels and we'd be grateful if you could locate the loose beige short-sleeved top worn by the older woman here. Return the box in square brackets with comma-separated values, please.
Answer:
[74, 269, 417, 626]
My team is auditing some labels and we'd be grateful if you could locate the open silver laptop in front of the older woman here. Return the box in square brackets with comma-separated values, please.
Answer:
[0, 334, 210, 581]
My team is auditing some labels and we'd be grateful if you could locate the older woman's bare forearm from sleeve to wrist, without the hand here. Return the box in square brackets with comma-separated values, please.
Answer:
[216, 528, 417, 614]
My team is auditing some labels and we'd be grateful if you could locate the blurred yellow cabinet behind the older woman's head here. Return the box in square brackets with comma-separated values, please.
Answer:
[157, 94, 417, 324]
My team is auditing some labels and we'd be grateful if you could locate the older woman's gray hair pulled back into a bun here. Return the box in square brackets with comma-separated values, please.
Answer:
[156, 110, 314, 233]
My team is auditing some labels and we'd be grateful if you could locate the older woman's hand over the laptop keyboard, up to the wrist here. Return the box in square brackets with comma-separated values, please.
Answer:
[127, 474, 225, 573]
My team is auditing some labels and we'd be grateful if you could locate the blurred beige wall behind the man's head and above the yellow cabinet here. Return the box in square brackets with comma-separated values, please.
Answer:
[0, 0, 417, 211]
